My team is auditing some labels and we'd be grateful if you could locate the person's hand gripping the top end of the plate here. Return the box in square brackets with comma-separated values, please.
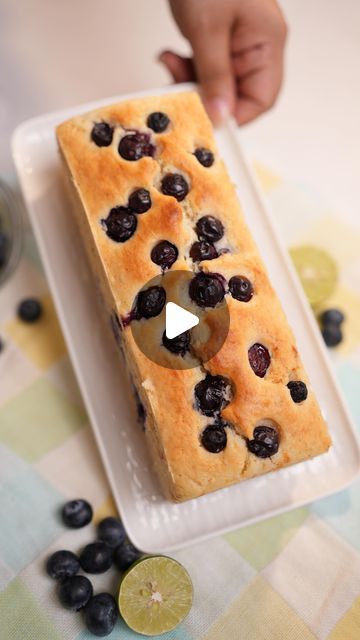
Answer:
[159, 0, 287, 124]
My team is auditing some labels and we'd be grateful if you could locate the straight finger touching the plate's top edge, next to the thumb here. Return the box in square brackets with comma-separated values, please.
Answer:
[191, 29, 235, 125]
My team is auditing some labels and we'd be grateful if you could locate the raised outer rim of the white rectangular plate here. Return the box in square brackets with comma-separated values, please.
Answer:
[11, 83, 360, 553]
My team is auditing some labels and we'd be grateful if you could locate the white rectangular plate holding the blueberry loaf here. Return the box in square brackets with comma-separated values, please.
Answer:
[13, 86, 360, 553]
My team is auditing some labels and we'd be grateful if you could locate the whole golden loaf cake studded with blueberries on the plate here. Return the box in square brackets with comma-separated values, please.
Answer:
[57, 92, 331, 501]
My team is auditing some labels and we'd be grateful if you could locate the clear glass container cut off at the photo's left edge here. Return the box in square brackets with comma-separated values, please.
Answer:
[0, 178, 23, 286]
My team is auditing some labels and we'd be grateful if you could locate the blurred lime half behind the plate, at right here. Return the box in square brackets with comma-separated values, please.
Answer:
[290, 245, 338, 307]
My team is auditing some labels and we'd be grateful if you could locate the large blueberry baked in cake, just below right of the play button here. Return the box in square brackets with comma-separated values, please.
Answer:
[195, 374, 232, 416]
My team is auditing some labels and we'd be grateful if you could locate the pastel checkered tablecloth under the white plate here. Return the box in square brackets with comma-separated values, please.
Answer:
[0, 166, 360, 640]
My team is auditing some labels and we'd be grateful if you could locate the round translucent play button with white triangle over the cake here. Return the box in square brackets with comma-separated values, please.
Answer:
[129, 269, 230, 369]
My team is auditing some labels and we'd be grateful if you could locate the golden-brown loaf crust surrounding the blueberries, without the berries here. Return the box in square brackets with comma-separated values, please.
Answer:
[57, 92, 331, 500]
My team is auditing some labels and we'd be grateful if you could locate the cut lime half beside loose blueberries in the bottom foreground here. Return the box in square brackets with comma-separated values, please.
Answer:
[119, 556, 193, 636]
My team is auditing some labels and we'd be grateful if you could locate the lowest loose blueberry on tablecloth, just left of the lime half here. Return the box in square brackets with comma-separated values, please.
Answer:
[84, 593, 119, 637]
